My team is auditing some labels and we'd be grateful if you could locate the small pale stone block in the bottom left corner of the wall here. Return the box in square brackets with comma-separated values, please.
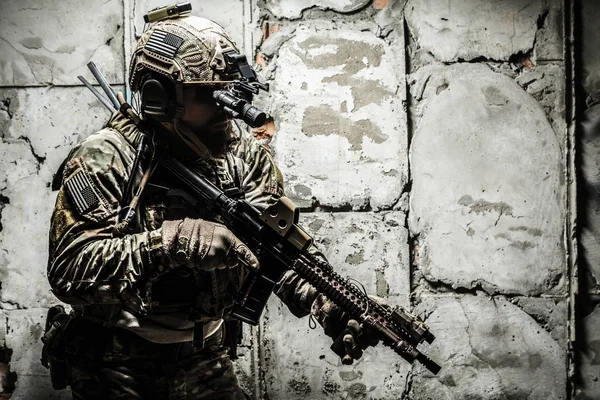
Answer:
[0, 308, 71, 400]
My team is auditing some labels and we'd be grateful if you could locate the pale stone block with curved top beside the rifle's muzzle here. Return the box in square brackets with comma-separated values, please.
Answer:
[409, 296, 567, 400]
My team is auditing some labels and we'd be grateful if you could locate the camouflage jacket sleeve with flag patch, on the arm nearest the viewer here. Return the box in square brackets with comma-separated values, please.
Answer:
[48, 130, 162, 304]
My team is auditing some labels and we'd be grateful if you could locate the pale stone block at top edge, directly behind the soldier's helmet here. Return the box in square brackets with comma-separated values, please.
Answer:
[127, 0, 245, 57]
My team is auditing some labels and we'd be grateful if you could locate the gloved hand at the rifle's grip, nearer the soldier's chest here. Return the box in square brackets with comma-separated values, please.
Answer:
[162, 218, 259, 271]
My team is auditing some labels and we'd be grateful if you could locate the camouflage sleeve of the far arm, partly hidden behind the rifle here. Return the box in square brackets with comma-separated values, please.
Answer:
[236, 132, 318, 317]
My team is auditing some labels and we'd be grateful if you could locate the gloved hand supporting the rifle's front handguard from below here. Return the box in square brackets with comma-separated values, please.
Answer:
[311, 294, 385, 365]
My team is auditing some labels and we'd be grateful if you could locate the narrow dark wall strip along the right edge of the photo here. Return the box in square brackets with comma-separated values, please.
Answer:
[576, 0, 600, 400]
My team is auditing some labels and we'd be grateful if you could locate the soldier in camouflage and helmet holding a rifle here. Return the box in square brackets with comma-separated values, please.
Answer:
[48, 9, 380, 400]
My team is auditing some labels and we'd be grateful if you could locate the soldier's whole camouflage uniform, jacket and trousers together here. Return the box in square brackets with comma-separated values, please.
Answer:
[48, 112, 316, 399]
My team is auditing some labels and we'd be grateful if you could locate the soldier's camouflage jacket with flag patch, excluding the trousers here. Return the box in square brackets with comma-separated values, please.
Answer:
[48, 112, 315, 343]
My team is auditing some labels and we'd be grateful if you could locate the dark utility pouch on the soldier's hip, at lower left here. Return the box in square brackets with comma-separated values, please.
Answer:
[41, 305, 73, 390]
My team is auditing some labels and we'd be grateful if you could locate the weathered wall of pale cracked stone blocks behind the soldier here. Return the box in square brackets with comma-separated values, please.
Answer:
[0, 0, 600, 400]
